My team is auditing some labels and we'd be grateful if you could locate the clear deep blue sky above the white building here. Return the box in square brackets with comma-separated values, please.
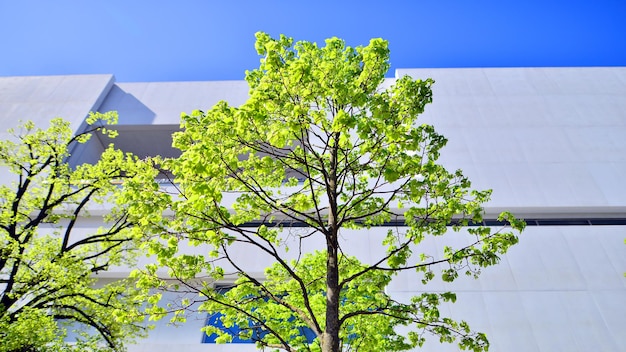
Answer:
[0, 0, 626, 82]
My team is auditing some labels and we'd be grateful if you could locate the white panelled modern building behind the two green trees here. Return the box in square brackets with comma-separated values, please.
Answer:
[0, 67, 626, 352]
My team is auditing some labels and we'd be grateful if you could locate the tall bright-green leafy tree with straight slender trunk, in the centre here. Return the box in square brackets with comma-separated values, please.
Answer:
[134, 33, 524, 352]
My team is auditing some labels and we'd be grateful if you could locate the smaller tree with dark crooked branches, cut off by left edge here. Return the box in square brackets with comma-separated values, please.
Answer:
[0, 113, 154, 352]
